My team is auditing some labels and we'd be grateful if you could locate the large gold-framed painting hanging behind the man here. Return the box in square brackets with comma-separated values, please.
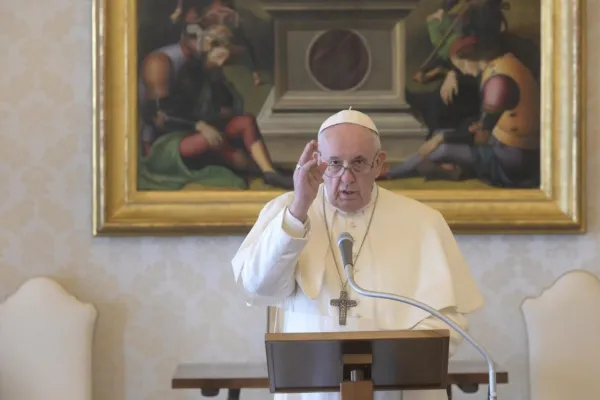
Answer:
[94, 0, 585, 234]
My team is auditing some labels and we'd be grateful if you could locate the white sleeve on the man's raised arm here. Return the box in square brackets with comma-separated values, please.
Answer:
[232, 195, 310, 301]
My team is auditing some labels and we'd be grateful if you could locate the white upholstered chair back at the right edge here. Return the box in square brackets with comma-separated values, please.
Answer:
[521, 270, 600, 400]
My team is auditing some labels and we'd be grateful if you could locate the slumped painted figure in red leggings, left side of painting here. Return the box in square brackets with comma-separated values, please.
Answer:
[140, 19, 293, 189]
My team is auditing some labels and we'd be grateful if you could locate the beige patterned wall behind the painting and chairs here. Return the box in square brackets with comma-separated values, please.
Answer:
[0, 0, 600, 400]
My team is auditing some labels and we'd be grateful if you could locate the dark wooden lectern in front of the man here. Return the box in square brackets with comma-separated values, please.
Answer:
[265, 330, 450, 400]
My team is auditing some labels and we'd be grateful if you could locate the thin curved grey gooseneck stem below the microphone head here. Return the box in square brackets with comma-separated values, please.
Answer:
[344, 263, 497, 400]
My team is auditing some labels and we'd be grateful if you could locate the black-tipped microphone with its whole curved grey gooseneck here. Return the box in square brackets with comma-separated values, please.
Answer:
[338, 239, 497, 400]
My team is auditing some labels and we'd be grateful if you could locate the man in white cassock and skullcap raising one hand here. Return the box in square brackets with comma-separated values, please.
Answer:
[232, 109, 483, 400]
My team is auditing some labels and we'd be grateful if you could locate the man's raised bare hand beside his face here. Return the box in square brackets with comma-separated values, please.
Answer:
[289, 140, 327, 222]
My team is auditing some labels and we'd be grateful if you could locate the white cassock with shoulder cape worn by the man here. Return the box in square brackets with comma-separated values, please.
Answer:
[232, 185, 483, 400]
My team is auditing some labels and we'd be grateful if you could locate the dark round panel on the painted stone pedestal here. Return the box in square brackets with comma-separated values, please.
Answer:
[307, 29, 370, 90]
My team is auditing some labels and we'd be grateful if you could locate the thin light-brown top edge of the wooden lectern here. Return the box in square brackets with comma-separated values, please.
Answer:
[265, 329, 450, 342]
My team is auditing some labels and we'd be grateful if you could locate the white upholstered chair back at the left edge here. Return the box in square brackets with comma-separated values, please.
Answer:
[0, 277, 97, 400]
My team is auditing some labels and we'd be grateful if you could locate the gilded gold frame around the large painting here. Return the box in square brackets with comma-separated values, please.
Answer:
[93, 0, 586, 235]
